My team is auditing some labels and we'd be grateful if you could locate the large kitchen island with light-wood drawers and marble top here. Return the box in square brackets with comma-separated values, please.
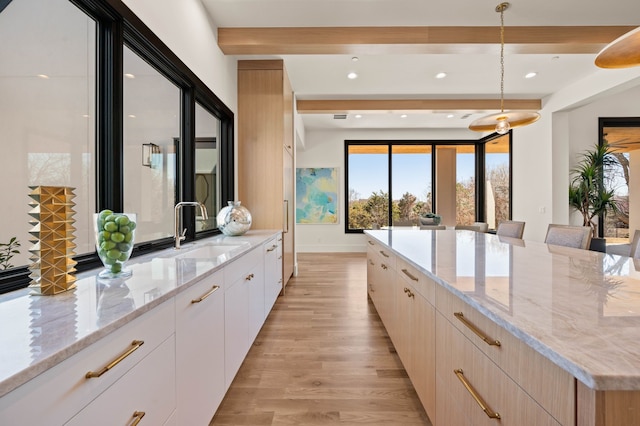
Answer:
[366, 229, 640, 425]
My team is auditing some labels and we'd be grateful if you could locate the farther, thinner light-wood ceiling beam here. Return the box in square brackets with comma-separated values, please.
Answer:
[296, 99, 542, 114]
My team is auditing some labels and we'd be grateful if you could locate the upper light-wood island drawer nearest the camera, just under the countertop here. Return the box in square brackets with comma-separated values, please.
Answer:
[436, 286, 575, 425]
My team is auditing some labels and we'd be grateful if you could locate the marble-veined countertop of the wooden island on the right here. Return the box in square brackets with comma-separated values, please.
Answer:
[366, 229, 640, 390]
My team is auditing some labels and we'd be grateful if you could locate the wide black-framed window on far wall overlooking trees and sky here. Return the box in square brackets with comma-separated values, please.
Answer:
[345, 137, 511, 232]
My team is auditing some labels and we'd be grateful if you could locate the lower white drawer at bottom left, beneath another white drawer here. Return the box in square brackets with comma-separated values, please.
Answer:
[67, 335, 176, 426]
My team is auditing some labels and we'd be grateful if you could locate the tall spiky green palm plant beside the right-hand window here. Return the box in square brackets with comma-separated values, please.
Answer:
[569, 142, 619, 252]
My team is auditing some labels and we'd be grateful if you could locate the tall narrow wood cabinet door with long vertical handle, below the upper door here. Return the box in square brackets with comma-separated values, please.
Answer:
[282, 147, 295, 289]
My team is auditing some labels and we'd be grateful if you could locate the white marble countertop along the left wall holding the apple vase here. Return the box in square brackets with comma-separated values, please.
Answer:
[0, 230, 279, 397]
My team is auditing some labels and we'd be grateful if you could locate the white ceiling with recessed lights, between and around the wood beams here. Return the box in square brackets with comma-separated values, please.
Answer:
[202, 0, 640, 128]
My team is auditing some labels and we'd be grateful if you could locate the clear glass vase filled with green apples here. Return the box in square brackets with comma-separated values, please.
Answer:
[94, 210, 136, 278]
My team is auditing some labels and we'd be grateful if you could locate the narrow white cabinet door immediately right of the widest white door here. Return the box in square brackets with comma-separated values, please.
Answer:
[224, 277, 250, 389]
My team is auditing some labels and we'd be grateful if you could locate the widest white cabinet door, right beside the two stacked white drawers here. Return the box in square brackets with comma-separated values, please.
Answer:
[175, 271, 226, 425]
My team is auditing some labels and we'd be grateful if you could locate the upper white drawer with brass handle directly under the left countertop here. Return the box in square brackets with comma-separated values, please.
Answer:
[0, 299, 175, 426]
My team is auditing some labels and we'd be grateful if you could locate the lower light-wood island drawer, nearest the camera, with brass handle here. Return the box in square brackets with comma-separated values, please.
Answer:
[436, 314, 560, 426]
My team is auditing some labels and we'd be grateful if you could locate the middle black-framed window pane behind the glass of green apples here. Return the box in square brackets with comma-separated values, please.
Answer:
[122, 47, 181, 243]
